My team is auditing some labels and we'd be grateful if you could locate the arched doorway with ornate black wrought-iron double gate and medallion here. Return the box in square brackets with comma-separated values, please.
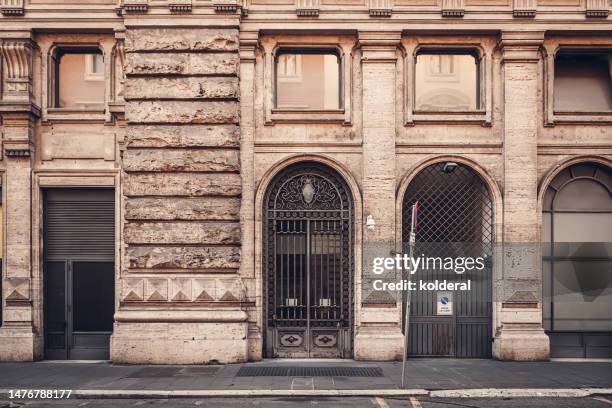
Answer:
[263, 161, 354, 358]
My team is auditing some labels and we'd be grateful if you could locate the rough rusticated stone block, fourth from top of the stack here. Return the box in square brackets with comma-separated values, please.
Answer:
[125, 101, 239, 124]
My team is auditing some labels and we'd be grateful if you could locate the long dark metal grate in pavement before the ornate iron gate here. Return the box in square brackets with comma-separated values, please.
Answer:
[236, 367, 383, 377]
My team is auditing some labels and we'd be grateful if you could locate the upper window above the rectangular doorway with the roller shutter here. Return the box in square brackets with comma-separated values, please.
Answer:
[55, 49, 105, 110]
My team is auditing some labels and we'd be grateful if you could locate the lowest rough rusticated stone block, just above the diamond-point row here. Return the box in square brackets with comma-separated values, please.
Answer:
[127, 246, 240, 269]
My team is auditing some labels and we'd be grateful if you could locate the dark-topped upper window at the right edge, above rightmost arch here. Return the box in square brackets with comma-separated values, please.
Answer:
[554, 52, 612, 112]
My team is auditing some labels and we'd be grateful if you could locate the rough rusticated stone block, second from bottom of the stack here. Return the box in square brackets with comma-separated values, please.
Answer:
[124, 221, 240, 245]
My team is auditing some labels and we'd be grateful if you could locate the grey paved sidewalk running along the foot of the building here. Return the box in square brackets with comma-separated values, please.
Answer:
[0, 359, 612, 398]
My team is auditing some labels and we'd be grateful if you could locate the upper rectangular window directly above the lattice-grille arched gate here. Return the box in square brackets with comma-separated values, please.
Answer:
[414, 51, 480, 112]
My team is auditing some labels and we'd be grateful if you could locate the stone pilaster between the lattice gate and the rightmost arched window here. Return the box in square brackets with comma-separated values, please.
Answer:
[493, 31, 549, 360]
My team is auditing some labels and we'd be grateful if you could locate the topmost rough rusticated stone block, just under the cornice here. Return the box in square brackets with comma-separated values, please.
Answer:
[125, 27, 238, 52]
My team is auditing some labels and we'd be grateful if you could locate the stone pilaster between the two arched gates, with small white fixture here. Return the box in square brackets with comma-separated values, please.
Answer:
[355, 31, 403, 360]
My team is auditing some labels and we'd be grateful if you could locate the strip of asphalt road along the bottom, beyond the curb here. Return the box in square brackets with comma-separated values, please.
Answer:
[0, 397, 612, 408]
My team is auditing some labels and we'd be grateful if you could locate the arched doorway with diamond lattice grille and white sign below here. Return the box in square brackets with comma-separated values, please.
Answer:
[402, 162, 494, 358]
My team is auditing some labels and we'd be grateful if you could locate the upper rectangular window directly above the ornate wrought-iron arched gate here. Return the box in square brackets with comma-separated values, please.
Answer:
[275, 50, 342, 110]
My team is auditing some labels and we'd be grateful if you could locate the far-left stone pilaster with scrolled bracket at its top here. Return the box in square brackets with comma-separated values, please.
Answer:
[0, 32, 41, 361]
